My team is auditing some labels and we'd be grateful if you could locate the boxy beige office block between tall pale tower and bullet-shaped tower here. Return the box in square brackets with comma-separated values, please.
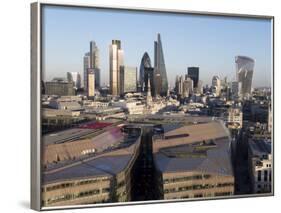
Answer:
[120, 66, 137, 94]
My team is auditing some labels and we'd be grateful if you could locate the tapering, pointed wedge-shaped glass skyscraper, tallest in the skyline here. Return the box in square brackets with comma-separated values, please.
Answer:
[154, 33, 168, 95]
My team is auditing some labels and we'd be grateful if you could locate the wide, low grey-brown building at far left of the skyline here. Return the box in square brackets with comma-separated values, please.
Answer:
[45, 78, 75, 96]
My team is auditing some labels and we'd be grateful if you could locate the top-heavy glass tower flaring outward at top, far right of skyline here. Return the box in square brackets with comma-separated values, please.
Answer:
[235, 56, 255, 98]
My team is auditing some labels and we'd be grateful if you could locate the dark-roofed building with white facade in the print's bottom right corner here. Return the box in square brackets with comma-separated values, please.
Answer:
[248, 140, 272, 193]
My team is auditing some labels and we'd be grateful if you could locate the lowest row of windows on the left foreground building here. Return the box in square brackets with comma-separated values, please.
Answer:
[47, 188, 110, 204]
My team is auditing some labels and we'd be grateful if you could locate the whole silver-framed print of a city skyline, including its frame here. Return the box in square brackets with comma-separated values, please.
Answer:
[31, 2, 274, 210]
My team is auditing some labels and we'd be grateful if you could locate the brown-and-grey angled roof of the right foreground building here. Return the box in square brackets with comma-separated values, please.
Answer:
[153, 121, 233, 176]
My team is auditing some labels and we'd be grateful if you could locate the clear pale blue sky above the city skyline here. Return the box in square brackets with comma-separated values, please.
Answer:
[43, 6, 272, 86]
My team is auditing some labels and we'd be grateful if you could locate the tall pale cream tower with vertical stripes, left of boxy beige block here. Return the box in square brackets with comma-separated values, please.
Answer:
[109, 40, 124, 96]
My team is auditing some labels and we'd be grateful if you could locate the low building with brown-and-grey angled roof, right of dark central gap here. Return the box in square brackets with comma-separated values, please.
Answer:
[153, 121, 234, 199]
